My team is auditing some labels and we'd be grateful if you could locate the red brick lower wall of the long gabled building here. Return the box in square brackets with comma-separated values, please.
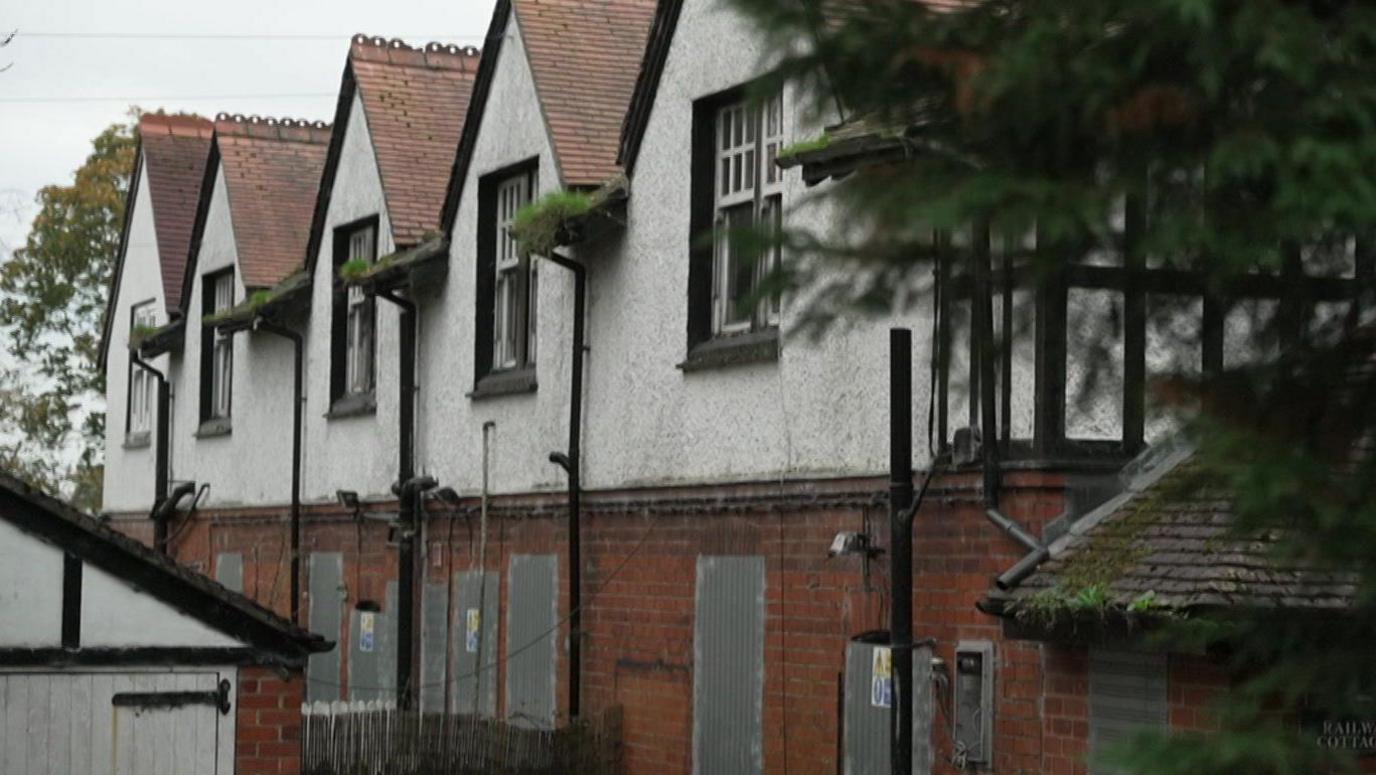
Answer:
[110, 472, 1238, 775]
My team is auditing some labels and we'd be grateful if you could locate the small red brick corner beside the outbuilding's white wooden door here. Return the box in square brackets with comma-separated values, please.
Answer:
[234, 668, 305, 775]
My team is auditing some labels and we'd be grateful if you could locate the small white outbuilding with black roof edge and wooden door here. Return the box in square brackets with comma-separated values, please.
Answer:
[0, 475, 333, 775]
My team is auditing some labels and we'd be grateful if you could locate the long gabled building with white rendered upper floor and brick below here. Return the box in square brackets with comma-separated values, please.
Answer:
[91, 0, 1368, 772]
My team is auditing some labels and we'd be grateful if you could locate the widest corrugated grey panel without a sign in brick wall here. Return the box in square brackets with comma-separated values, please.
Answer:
[694, 556, 765, 775]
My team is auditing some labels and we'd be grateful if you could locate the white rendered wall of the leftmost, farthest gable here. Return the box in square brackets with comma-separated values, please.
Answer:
[102, 158, 169, 512]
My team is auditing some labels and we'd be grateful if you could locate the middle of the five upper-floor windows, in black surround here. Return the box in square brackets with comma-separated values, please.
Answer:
[330, 216, 377, 410]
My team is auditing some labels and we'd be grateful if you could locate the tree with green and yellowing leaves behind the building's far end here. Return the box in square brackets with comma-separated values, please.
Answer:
[0, 112, 135, 508]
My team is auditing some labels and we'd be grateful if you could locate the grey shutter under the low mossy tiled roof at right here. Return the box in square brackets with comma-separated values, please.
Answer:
[1090, 648, 1170, 775]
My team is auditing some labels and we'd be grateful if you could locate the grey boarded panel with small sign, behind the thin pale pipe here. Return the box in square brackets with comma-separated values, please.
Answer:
[451, 570, 502, 716]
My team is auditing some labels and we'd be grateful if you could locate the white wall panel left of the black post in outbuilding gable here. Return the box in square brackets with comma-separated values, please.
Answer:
[0, 520, 62, 648]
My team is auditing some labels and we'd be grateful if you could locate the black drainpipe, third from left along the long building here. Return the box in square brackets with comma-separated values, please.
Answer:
[376, 290, 418, 710]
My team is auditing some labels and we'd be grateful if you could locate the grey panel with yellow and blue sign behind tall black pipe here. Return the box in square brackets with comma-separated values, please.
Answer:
[843, 641, 933, 775]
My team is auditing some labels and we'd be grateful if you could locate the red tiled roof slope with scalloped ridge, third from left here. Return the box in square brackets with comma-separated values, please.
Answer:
[350, 34, 479, 245]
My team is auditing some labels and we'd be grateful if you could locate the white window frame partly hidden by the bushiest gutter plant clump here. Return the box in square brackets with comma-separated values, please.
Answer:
[491, 171, 539, 372]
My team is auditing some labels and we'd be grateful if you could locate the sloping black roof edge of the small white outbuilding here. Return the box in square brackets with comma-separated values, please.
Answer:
[0, 472, 334, 663]
